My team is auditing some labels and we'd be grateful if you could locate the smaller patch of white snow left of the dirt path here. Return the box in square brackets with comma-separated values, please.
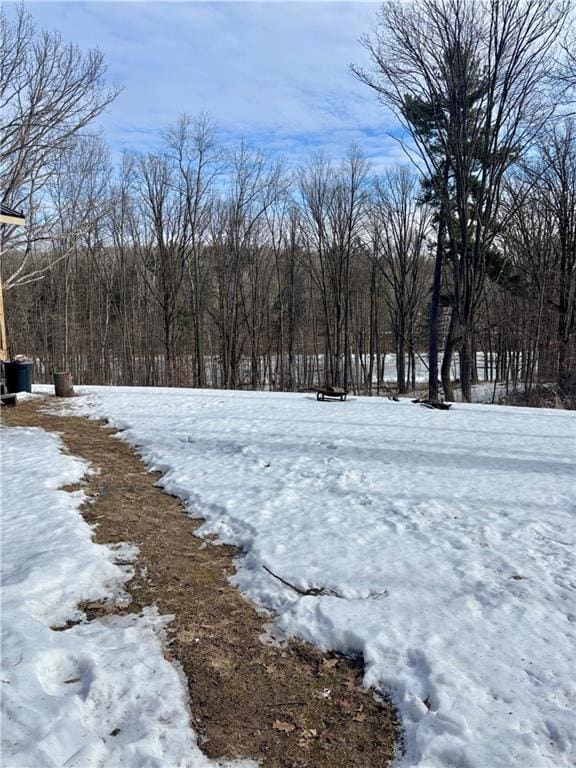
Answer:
[0, 428, 254, 768]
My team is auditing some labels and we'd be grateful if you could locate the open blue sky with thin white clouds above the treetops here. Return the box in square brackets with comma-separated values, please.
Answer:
[25, 0, 406, 170]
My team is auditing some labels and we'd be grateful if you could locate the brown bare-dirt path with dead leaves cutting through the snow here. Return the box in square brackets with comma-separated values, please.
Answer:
[2, 401, 399, 768]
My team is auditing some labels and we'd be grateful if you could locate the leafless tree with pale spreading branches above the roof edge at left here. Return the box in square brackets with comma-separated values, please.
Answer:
[0, 7, 118, 288]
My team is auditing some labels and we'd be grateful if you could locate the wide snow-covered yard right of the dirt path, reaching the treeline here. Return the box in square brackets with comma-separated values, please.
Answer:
[53, 387, 576, 768]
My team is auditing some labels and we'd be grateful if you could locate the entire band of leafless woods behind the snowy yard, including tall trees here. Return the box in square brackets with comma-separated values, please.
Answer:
[0, 0, 576, 405]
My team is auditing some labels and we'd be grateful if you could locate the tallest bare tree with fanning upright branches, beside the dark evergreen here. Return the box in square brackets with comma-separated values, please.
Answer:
[354, 0, 568, 400]
